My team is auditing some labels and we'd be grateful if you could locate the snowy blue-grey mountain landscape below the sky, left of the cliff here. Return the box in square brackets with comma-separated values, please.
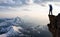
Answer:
[0, 17, 52, 37]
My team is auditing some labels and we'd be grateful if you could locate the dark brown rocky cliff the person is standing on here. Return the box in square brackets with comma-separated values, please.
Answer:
[47, 14, 60, 37]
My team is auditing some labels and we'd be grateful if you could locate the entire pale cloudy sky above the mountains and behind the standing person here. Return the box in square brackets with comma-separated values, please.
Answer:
[0, 0, 60, 24]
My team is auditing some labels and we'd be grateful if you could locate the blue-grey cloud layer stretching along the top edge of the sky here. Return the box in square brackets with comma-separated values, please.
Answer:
[0, 0, 59, 7]
